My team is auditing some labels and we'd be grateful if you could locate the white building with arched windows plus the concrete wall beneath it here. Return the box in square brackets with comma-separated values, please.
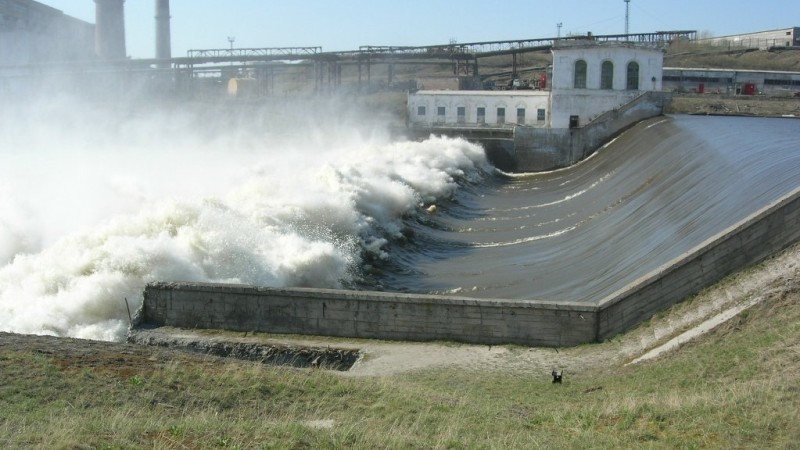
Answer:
[407, 40, 669, 172]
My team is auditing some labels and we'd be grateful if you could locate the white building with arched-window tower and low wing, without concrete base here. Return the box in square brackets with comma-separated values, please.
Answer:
[408, 41, 664, 128]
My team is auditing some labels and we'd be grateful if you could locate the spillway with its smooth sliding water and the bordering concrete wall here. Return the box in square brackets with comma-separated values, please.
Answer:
[134, 116, 800, 346]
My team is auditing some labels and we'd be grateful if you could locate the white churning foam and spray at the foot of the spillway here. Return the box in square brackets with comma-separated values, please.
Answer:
[0, 96, 488, 340]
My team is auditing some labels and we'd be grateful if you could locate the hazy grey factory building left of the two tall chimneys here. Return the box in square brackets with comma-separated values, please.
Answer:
[0, 0, 95, 65]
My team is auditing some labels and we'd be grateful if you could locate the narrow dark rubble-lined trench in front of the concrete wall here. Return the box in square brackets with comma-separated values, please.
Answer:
[128, 334, 361, 372]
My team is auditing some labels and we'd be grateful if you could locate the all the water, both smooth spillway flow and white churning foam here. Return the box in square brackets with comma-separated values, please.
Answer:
[0, 96, 800, 340]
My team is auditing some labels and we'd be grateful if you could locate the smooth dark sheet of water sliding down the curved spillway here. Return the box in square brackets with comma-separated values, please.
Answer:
[387, 116, 800, 302]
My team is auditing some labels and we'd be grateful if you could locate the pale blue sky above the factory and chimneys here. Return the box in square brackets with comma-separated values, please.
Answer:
[39, 0, 800, 58]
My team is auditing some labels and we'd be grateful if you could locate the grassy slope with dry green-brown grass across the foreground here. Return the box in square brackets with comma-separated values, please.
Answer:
[0, 253, 800, 449]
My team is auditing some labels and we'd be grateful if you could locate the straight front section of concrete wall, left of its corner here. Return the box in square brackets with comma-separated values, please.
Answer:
[138, 283, 597, 346]
